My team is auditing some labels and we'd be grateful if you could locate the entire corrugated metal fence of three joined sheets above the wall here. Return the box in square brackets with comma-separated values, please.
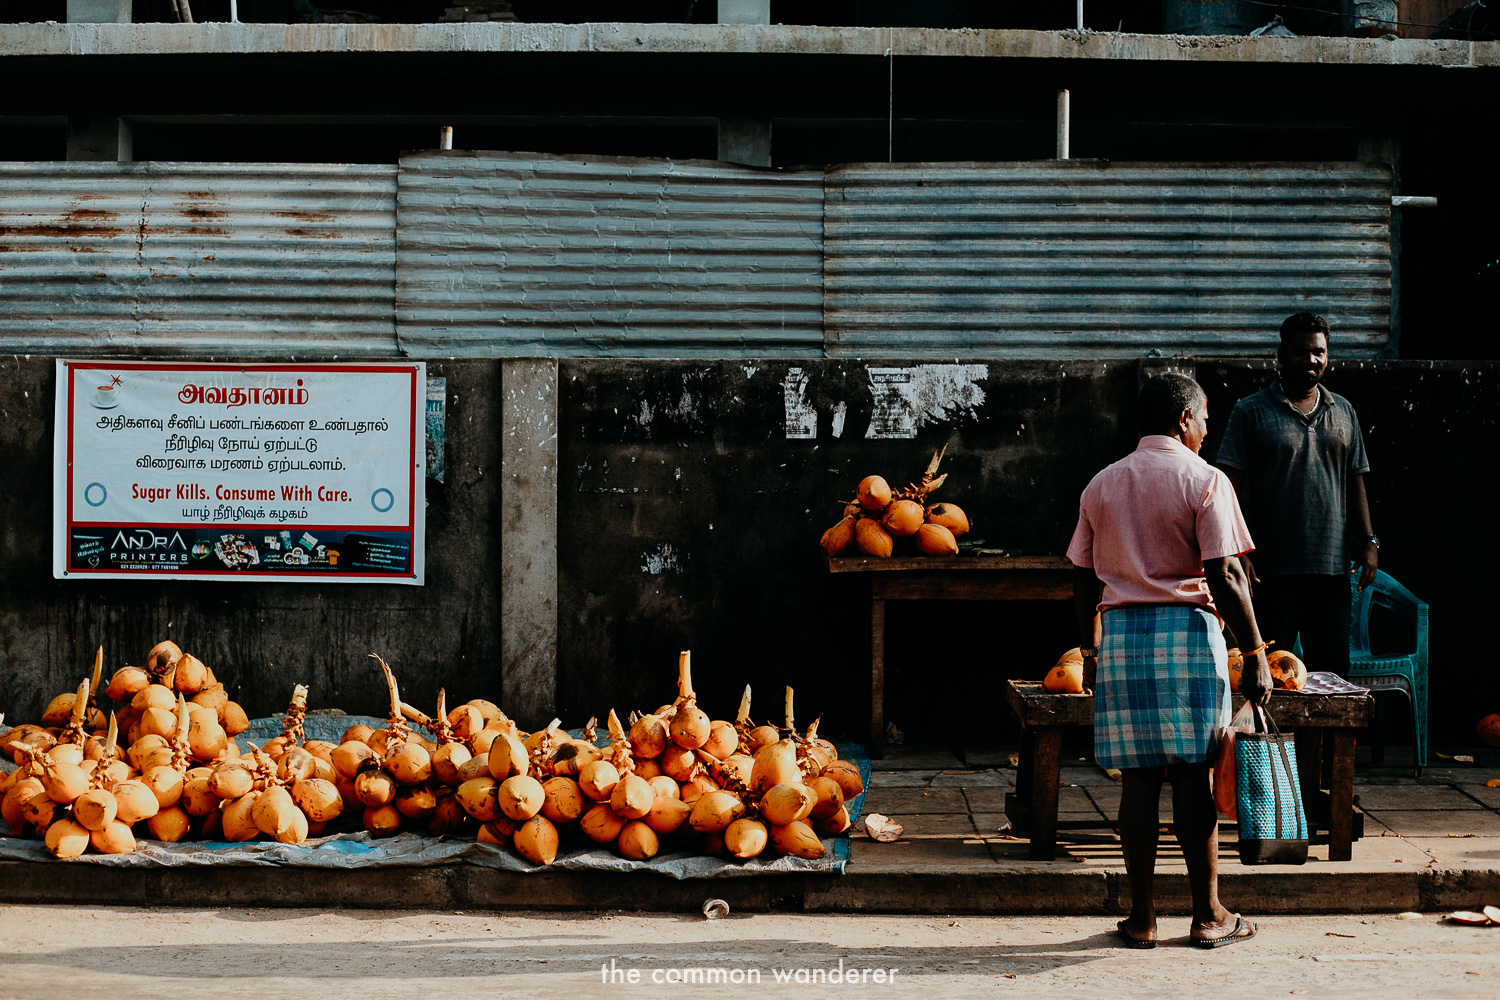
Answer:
[0, 153, 1391, 358]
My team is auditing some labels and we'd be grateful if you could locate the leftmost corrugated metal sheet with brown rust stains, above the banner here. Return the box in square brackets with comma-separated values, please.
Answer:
[0, 162, 396, 357]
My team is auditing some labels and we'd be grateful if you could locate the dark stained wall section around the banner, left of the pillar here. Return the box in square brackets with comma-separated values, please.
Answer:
[0, 357, 501, 723]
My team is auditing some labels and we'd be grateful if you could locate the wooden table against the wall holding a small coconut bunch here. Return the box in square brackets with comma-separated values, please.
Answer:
[828, 556, 1073, 757]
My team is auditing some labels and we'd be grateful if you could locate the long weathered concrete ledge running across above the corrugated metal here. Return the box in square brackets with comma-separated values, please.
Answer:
[0, 22, 1500, 67]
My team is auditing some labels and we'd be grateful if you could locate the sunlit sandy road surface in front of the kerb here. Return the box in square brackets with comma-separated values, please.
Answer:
[0, 906, 1500, 1000]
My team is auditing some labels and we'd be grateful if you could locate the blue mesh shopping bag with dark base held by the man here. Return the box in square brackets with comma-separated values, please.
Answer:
[1235, 706, 1308, 865]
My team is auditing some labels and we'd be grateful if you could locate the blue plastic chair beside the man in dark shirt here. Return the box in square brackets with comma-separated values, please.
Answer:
[1349, 570, 1427, 775]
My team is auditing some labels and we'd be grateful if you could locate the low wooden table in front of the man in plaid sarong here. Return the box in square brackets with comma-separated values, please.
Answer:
[1005, 681, 1374, 861]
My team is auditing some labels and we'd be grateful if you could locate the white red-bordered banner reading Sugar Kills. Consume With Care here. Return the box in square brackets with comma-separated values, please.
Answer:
[53, 361, 428, 585]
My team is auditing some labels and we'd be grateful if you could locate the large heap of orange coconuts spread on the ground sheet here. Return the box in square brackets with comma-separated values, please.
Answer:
[0, 643, 864, 865]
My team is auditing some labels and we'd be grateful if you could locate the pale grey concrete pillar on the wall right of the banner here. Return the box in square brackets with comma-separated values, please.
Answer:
[500, 358, 558, 729]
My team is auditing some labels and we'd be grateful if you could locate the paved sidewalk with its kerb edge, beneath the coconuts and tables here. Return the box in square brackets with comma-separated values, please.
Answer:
[11, 747, 1500, 917]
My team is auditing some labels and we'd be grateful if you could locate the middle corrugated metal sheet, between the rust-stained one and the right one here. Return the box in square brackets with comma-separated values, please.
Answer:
[396, 153, 824, 357]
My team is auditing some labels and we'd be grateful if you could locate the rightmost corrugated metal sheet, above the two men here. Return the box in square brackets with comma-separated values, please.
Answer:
[825, 160, 1391, 358]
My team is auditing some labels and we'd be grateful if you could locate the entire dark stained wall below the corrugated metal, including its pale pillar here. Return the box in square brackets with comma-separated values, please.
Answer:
[0, 358, 1476, 750]
